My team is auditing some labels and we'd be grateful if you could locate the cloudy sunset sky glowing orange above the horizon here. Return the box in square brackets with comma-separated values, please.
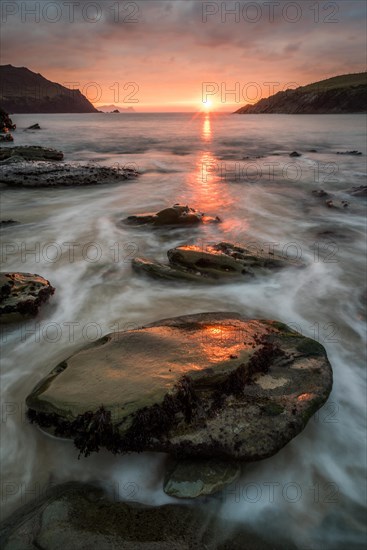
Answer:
[1, 0, 367, 112]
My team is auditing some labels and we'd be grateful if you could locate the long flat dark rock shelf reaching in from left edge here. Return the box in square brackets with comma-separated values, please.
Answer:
[0, 163, 138, 187]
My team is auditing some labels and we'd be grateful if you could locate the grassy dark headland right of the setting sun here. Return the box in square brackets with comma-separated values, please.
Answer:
[235, 73, 367, 115]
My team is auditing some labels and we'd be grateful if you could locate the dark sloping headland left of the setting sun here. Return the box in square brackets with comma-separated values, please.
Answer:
[0, 65, 98, 113]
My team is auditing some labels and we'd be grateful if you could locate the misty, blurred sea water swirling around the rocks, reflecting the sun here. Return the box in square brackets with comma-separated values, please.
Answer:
[0, 114, 366, 550]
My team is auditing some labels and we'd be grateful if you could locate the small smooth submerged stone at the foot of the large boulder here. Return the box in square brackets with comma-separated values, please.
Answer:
[164, 458, 241, 498]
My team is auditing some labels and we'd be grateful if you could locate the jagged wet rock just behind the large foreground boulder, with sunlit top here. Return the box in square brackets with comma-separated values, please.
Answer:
[132, 242, 303, 284]
